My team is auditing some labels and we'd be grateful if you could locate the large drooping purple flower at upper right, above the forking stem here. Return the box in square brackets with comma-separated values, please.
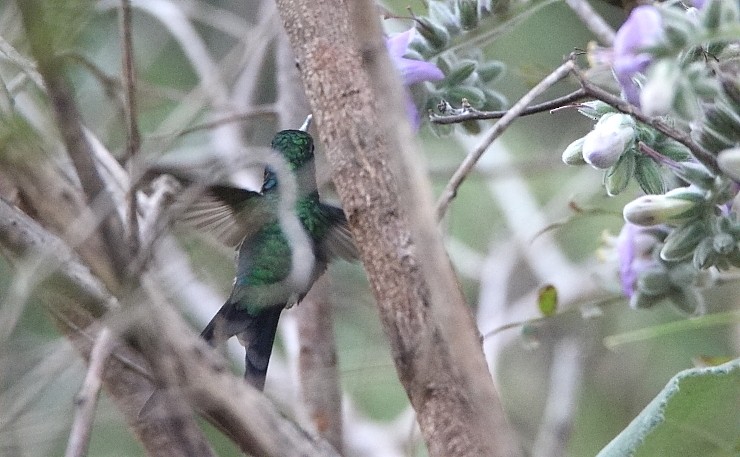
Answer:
[612, 5, 663, 106]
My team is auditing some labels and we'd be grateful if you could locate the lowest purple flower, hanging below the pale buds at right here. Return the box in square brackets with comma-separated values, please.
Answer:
[616, 222, 662, 298]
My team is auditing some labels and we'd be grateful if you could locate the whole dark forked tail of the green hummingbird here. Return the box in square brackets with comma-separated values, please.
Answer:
[200, 302, 283, 390]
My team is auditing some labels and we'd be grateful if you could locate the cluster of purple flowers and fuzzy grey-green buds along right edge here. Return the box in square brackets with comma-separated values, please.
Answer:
[563, 0, 740, 313]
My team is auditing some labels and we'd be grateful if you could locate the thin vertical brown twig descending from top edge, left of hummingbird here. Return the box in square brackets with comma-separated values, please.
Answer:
[119, 0, 141, 255]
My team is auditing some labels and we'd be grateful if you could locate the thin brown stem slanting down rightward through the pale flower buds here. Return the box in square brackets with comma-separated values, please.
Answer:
[572, 66, 721, 174]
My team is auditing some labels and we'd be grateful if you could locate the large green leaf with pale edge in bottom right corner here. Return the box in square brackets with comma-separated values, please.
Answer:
[597, 359, 740, 457]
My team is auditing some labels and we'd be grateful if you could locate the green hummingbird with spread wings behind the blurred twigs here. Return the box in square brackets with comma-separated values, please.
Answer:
[185, 130, 357, 390]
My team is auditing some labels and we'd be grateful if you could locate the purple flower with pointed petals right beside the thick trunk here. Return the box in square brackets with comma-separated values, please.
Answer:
[385, 28, 445, 130]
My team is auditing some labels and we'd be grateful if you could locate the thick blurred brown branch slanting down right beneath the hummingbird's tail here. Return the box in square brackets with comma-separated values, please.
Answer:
[142, 274, 338, 457]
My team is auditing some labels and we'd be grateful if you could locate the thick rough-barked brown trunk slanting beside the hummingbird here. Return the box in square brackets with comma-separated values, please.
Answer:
[277, 0, 519, 456]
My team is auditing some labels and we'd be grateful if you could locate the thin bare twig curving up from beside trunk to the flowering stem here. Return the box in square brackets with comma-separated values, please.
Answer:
[437, 59, 575, 219]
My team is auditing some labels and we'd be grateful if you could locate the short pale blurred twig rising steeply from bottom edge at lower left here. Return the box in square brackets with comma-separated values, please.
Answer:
[64, 328, 113, 457]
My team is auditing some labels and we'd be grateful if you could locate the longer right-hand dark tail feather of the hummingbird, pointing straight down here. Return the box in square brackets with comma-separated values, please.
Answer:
[244, 306, 283, 390]
